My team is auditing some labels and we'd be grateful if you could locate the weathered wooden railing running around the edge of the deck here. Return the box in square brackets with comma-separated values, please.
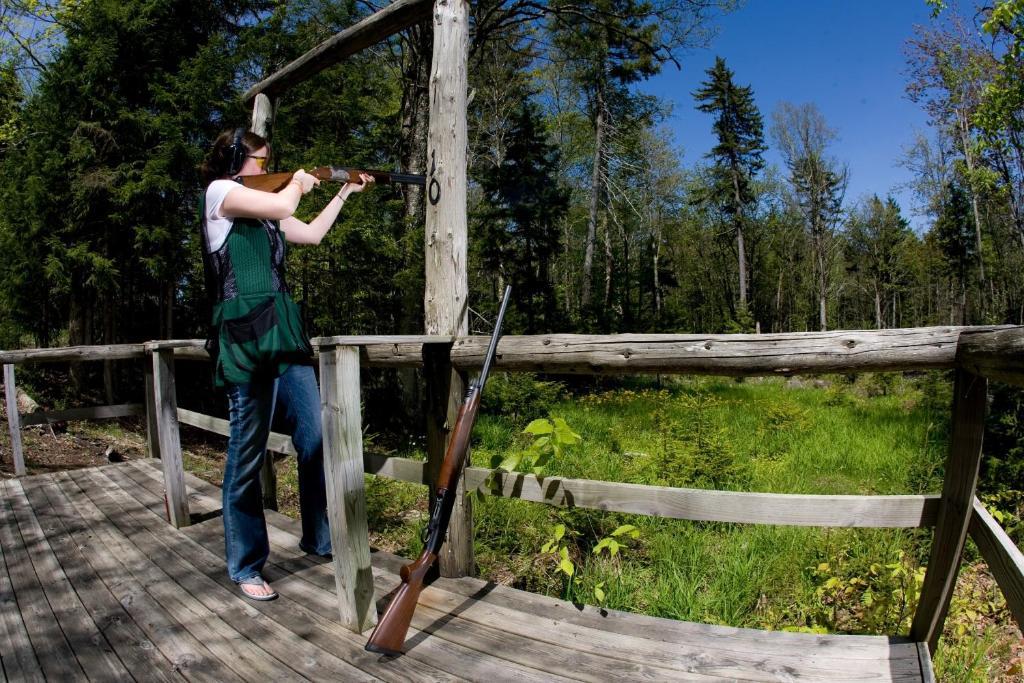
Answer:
[6, 327, 1024, 651]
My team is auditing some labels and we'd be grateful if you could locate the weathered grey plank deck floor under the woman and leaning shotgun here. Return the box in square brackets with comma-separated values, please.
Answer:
[0, 461, 934, 682]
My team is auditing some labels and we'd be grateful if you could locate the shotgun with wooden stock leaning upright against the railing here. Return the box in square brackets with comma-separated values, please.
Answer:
[367, 287, 512, 654]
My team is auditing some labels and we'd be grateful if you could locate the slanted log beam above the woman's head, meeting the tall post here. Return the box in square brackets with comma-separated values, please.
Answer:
[242, 0, 431, 102]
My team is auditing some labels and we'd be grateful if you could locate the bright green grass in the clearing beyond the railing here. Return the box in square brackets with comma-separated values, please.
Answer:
[358, 376, 1007, 681]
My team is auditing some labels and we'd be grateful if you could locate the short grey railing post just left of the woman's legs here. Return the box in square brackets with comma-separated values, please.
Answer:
[153, 348, 190, 528]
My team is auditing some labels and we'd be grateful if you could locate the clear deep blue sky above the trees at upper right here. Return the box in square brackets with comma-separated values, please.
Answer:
[643, 0, 954, 229]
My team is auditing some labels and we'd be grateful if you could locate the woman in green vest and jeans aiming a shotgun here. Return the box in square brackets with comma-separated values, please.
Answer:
[202, 128, 374, 600]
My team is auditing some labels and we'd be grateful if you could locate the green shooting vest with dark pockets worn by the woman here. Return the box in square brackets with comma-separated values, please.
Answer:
[200, 193, 312, 387]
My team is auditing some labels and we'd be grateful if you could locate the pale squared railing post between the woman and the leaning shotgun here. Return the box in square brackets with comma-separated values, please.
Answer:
[321, 346, 377, 633]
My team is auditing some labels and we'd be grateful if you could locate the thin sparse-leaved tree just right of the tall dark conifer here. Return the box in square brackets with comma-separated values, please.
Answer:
[772, 102, 847, 331]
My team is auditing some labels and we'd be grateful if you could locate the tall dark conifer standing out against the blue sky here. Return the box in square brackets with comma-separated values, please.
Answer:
[693, 57, 767, 311]
